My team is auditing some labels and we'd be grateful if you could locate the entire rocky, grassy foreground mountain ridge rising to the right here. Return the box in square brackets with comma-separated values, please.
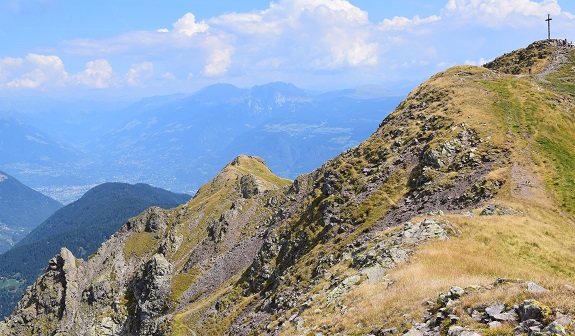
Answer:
[0, 42, 575, 335]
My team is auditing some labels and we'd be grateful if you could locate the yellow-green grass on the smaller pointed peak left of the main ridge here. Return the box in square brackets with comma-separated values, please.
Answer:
[118, 155, 292, 335]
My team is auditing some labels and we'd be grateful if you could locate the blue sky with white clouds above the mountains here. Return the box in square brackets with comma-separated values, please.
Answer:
[0, 0, 575, 97]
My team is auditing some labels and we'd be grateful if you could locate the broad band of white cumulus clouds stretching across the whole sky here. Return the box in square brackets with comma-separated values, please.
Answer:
[10, 0, 575, 90]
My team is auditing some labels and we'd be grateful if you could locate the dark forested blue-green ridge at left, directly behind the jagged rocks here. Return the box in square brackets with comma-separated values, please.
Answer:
[0, 183, 191, 315]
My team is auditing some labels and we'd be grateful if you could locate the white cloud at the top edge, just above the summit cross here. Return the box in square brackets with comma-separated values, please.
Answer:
[443, 0, 561, 27]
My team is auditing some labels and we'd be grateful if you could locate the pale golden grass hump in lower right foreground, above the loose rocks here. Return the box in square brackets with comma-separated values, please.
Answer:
[288, 202, 575, 335]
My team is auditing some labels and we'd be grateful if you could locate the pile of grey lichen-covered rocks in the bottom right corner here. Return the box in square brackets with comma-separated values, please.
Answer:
[410, 279, 573, 336]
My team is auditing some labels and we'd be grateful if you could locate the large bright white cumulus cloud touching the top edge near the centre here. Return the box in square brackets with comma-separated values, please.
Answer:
[208, 0, 378, 70]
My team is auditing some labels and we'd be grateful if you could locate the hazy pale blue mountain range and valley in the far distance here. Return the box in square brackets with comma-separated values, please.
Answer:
[0, 82, 402, 203]
